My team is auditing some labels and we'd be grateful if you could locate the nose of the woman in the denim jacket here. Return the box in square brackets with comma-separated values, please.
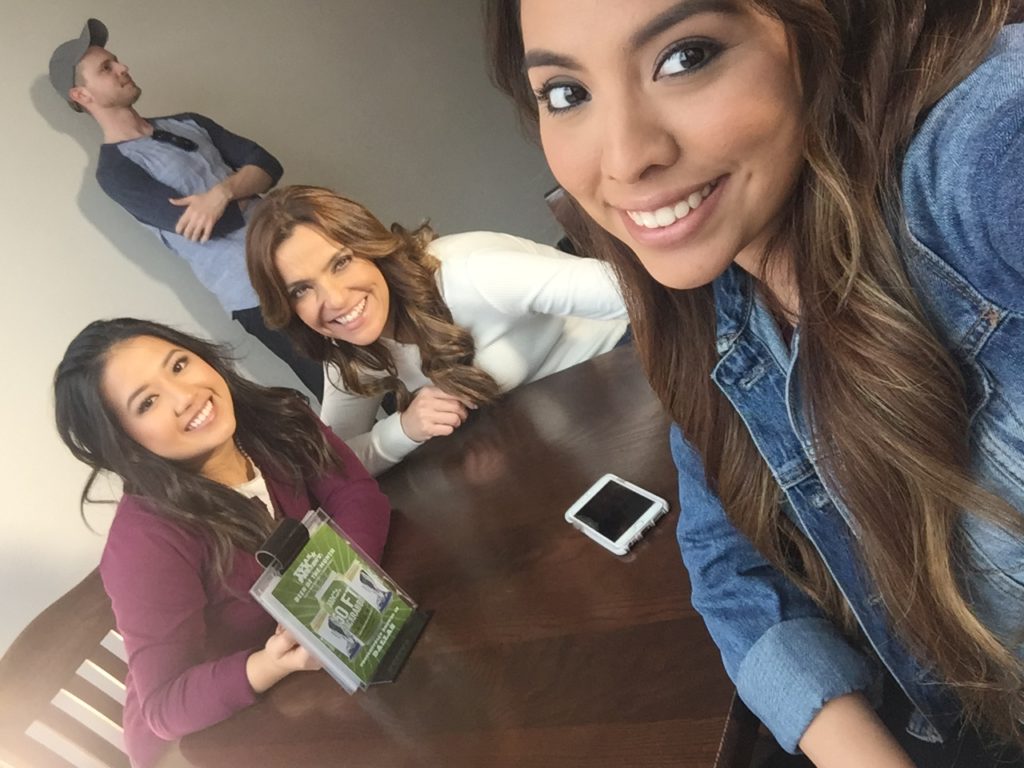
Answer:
[601, 91, 682, 183]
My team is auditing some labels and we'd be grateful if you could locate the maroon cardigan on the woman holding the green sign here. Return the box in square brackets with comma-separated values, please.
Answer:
[99, 428, 390, 766]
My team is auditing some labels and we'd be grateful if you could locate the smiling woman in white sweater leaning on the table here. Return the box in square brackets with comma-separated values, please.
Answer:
[246, 186, 628, 474]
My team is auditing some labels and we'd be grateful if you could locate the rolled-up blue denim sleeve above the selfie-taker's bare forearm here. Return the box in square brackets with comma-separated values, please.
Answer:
[671, 426, 878, 753]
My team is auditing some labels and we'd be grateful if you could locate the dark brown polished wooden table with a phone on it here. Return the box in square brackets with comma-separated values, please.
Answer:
[162, 348, 751, 768]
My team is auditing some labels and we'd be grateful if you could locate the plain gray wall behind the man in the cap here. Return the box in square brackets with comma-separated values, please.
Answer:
[0, 0, 557, 651]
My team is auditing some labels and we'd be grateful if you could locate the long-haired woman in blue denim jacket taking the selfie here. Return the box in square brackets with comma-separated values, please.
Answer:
[488, 0, 1024, 768]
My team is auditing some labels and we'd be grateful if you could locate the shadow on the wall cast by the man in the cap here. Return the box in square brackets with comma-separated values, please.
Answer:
[30, 76, 274, 378]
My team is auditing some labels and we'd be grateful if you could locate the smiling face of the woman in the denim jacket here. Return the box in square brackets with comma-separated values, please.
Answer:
[520, 0, 803, 289]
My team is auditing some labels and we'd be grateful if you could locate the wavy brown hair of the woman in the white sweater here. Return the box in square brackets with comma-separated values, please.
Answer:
[246, 185, 501, 411]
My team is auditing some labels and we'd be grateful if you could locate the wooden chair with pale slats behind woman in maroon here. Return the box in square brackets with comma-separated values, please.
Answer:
[0, 570, 129, 768]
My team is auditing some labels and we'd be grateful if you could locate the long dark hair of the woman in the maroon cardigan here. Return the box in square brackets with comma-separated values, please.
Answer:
[53, 317, 343, 579]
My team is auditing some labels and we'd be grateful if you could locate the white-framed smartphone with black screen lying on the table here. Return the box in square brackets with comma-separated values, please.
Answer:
[565, 474, 669, 555]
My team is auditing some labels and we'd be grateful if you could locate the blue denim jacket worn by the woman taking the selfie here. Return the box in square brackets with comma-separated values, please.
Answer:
[672, 25, 1024, 752]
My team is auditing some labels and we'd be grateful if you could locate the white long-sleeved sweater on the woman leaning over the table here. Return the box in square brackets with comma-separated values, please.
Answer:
[321, 232, 628, 474]
